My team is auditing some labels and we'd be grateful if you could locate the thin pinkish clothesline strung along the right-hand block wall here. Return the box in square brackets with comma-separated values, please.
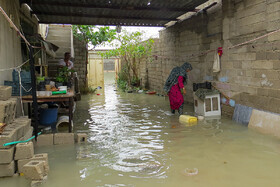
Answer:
[153, 29, 280, 60]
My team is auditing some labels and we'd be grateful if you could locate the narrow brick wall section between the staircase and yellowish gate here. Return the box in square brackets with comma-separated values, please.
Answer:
[74, 37, 87, 88]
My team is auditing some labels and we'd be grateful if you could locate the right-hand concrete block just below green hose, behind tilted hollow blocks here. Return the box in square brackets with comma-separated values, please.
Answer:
[15, 142, 34, 160]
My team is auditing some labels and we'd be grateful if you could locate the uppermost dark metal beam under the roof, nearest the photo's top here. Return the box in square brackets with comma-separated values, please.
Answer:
[21, 0, 199, 13]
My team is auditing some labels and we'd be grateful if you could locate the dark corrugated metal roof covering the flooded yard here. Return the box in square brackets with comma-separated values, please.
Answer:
[19, 0, 207, 26]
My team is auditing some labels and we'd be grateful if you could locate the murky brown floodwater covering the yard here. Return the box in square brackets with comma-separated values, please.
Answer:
[0, 73, 280, 187]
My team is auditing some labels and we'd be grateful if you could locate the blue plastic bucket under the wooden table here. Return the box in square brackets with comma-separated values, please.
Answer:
[39, 108, 58, 126]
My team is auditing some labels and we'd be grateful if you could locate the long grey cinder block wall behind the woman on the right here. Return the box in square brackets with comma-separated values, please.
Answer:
[140, 0, 280, 115]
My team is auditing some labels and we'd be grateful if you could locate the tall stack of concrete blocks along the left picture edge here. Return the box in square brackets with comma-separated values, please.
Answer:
[0, 86, 33, 177]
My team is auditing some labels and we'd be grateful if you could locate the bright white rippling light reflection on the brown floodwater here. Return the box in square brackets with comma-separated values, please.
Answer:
[87, 85, 167, 177]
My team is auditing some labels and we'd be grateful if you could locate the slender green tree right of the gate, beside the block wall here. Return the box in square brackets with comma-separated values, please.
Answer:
[100, 30, 154, 85]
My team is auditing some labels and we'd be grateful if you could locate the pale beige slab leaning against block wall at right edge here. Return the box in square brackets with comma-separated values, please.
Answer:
[248, 109, 280, 137]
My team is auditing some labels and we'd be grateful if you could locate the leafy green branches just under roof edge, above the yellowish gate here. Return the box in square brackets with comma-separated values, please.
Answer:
[72, 25, 116, 48]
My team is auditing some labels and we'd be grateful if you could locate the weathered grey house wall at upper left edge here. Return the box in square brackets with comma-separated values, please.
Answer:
[0, 0, 38, 85]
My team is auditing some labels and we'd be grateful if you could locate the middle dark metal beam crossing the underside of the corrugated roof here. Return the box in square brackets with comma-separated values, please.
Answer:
[32, 11, 178, 21]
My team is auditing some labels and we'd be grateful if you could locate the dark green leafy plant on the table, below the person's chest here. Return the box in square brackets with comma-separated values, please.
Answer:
[56, 66, 75, 87]
